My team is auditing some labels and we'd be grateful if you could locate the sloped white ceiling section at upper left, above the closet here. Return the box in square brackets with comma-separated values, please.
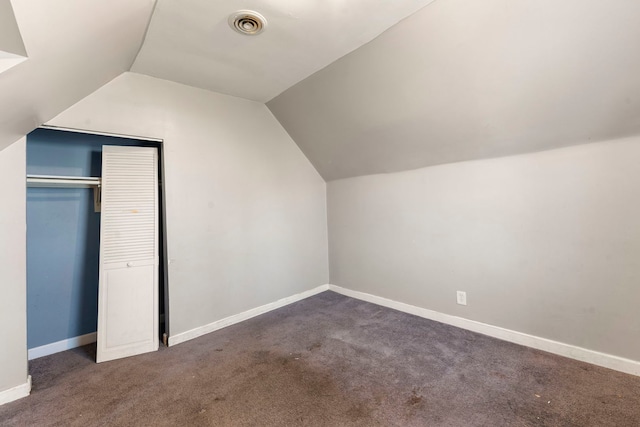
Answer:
[0, 0, 154, 150]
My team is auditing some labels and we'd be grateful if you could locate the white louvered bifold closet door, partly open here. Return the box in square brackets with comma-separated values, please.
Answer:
[96, 145, 159, 362]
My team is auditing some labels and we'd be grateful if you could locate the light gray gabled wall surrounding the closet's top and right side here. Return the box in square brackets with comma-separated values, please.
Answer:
[50, 73, 329, 335]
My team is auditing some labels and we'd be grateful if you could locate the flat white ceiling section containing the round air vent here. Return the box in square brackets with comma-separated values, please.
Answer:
[131, 0, 433, 102]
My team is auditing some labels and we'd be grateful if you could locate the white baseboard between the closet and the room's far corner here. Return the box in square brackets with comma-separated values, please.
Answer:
[169, 285, 329, 347]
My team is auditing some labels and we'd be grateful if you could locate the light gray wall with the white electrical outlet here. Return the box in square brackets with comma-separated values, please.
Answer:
[327, 137, 640, 360]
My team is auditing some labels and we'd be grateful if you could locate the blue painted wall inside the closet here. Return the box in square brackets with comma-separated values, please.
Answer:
[27, 129, 162, 349]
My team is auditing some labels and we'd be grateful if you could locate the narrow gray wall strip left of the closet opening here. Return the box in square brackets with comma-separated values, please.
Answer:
[0, 138, 27, 392]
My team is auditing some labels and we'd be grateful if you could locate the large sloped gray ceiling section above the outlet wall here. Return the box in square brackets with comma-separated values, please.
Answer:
[267, 0, 640, 180]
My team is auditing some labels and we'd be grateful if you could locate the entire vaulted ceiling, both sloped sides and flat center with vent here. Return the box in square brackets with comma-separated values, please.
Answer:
[0, 0, 640, 180]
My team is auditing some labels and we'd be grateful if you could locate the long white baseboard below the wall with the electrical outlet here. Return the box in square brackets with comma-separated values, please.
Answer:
[328, 285, 640, 376]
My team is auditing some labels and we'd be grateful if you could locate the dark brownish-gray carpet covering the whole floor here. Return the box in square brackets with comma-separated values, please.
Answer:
[0, 292, 640, 427]
